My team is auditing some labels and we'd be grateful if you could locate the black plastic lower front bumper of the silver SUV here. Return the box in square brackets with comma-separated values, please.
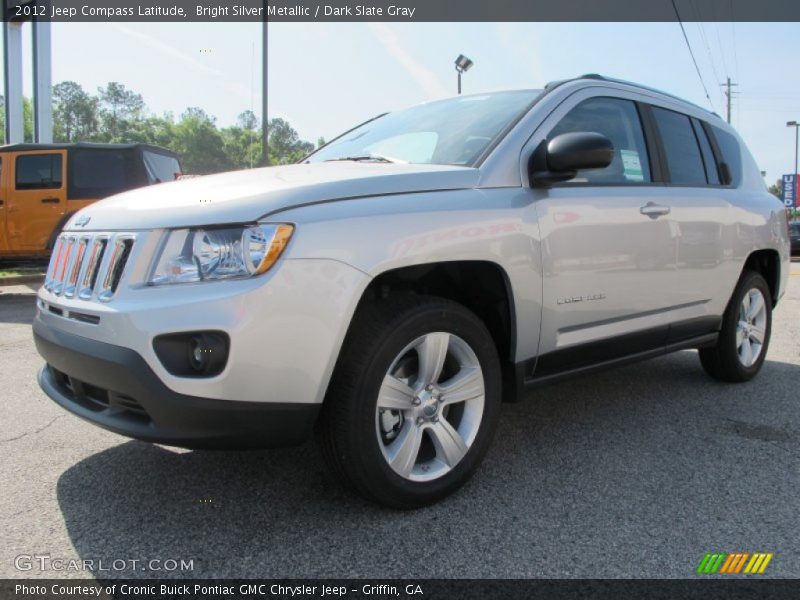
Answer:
[33, 317, 320, 448]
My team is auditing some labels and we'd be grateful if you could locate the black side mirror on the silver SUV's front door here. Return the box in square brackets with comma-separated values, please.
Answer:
[530, 131, 614, 186]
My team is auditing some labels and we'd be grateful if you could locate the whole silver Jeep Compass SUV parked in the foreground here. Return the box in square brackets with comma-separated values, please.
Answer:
[33, 75, 789, 507]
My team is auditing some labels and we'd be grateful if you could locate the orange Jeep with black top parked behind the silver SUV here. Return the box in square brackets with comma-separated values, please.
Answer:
[0, 143, 181, 258]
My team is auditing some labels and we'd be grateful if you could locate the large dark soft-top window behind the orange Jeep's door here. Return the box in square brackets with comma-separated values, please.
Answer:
[69, 149, 136, 200]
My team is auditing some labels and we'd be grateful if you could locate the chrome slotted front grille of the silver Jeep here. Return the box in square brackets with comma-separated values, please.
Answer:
[44, 233, 135, 302]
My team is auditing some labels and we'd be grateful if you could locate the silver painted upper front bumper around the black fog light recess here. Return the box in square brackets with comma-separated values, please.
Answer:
[37, 255, 369, 404]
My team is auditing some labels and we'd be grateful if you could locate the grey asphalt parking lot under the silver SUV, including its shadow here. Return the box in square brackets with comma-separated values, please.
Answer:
[0, 262, 800, 578]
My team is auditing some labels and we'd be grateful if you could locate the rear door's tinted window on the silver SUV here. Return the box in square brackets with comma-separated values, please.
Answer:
[653, 106, 707, 185]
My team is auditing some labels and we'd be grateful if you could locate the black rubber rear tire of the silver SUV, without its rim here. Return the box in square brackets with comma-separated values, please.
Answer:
[699, 271, 772, 383]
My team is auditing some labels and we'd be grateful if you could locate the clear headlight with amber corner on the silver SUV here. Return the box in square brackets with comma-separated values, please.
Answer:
[149, 224, 294, 285]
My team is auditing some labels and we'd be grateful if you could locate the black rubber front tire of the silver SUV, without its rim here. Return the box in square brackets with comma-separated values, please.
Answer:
[318, 295, 501, 509]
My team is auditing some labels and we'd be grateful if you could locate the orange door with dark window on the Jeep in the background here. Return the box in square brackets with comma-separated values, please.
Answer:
[4, 150, 66, 252]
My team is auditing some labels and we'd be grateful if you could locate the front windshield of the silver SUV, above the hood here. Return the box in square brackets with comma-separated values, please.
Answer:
[306, 90, 541, 166]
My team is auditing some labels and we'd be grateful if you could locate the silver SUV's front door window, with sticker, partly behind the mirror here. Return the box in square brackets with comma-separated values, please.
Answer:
[548, 98, 652, 184]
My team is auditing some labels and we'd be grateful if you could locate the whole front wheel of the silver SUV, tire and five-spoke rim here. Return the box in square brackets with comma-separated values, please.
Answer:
[320, 296, 501, 508]
